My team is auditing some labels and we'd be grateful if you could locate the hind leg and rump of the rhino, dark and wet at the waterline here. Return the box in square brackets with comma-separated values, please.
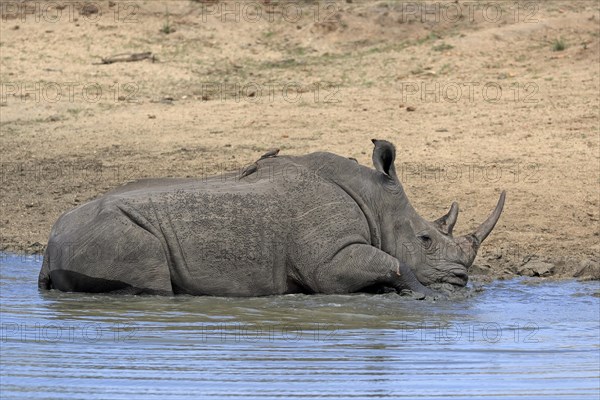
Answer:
[39, 206, 173, 294]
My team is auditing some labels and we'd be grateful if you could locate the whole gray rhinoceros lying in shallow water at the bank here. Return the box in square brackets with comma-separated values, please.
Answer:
[39, 140, 504, 296]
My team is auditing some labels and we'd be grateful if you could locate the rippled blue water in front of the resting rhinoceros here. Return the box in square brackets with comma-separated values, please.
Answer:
[0, 254, 600, 400]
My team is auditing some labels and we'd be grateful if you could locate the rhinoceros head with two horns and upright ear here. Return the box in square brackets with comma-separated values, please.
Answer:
[373, 139, 505, 286]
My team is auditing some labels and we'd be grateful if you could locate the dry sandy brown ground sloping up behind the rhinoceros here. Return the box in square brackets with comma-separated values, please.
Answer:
[0, 0, 600, 279]
